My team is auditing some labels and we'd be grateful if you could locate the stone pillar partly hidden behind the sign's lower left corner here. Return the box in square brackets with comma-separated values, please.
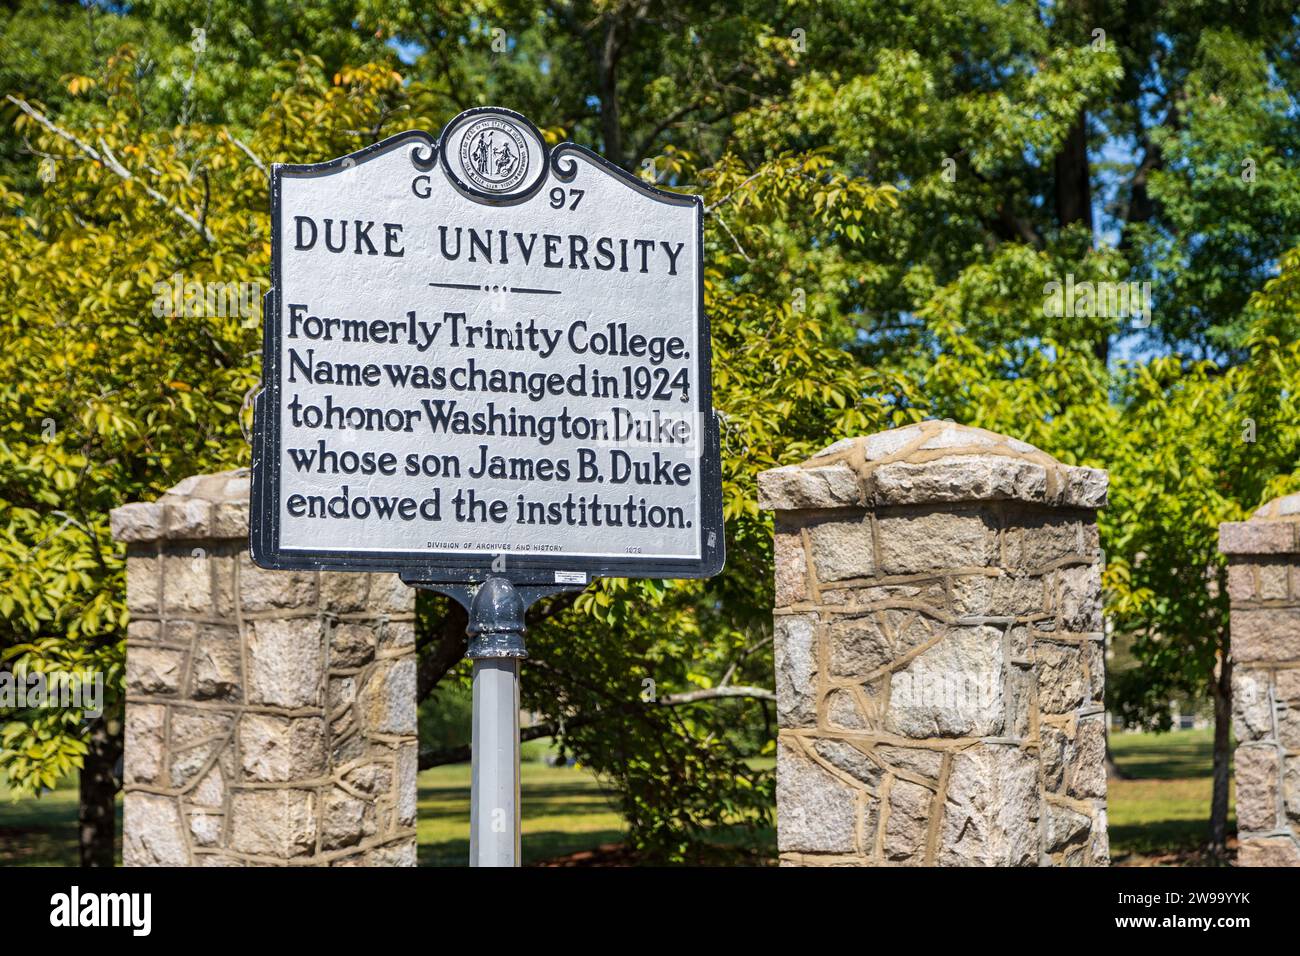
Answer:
[112, 471, 417, 866]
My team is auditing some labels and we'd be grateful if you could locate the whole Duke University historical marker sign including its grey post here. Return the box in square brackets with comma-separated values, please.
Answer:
[250, 108, 724, 866]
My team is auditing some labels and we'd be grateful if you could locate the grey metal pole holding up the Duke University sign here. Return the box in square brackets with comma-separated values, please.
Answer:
[465, 578, 528, 866]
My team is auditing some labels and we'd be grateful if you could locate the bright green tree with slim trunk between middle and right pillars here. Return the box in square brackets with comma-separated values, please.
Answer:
[924, 243, 1300, 853]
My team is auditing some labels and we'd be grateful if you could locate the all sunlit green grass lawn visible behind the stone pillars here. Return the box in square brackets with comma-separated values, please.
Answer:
[0, 730, 1236, 866]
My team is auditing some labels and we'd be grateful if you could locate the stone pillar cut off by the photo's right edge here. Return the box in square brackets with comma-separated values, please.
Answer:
[1219, 494, 1300, 866]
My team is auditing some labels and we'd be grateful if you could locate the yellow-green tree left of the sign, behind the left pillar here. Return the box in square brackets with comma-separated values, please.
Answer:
[0, 53, 268, 865]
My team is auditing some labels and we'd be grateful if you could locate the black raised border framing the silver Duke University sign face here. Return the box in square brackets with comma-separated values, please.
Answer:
[248, 115, 725, 584]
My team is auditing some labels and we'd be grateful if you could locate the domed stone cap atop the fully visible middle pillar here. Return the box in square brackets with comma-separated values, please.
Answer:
[758, 419, 1109, 511]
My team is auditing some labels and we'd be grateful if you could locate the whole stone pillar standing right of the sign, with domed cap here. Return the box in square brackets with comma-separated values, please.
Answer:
[759, 421, 1109, 866]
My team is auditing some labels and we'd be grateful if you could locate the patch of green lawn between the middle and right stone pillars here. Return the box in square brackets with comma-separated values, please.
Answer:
[1108, 730, 1236, 865]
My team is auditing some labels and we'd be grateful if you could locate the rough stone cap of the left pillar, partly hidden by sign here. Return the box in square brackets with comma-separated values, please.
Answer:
[108, 468, 250, 544]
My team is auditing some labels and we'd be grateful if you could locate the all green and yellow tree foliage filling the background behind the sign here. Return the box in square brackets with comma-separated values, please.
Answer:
[0, 0, 1300, 858]
